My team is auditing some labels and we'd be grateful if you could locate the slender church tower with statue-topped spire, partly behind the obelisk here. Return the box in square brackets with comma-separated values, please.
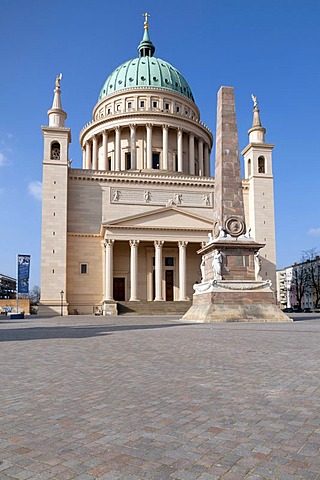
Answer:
[241, 95, 276, 286]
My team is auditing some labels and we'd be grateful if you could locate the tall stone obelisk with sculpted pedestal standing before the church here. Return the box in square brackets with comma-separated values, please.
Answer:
[183, 87, 291, 322]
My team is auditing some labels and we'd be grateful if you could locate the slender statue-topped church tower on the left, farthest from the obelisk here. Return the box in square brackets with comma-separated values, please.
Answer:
[40, 74, 71, 315]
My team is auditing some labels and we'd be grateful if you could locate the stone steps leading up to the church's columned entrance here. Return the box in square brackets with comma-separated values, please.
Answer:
[117, 300, 192, 315]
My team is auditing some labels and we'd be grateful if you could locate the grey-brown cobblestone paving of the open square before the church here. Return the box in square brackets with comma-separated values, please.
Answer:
[0, 316, 320, 480]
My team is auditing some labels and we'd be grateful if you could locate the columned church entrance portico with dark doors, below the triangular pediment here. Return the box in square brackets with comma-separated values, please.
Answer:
[103, 239, 201, 302]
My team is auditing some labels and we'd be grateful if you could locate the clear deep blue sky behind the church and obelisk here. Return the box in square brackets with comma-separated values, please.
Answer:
[0, 0, 320, 286]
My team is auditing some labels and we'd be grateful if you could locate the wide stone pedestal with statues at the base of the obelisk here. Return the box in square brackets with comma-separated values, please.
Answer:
[182, 239, 292, 322]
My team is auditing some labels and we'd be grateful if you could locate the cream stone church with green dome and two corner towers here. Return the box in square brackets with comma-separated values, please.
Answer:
[39, 14, 276, 315]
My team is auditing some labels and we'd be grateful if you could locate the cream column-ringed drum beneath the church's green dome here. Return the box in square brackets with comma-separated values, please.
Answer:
[80, 88, 212, 176]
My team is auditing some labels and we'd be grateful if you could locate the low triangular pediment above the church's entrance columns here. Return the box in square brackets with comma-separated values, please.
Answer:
[103, 207, 212, 231]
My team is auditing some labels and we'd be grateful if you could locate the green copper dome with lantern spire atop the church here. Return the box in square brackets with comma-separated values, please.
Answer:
[99, 21, 194, 102]
